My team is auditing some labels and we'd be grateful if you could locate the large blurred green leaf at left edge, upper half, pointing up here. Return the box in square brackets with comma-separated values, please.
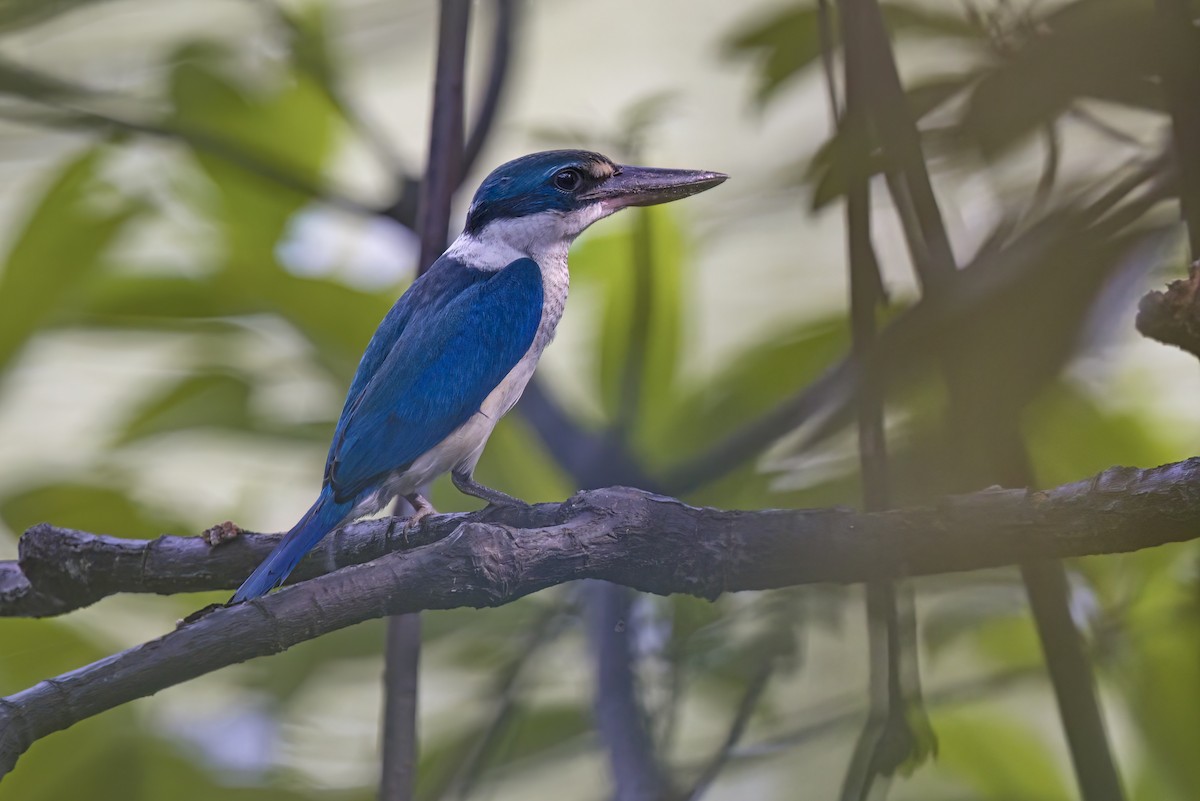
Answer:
[0, 146, 140, 369]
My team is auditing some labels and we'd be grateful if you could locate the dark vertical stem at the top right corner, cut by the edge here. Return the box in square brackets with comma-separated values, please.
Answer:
[1154, 0, 1200, 260]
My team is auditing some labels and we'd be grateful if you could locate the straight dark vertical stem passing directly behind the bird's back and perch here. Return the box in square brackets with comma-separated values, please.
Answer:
[379, 6, 470, 801]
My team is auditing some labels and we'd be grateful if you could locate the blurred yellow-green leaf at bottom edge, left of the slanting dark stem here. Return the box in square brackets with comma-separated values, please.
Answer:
[934, 709, 1074, 801]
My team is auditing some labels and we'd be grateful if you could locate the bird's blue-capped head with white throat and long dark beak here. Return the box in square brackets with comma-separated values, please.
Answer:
[464, 150, 728, 262]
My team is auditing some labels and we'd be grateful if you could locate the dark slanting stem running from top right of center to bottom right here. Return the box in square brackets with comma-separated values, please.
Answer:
[842, 0, 1123, 801]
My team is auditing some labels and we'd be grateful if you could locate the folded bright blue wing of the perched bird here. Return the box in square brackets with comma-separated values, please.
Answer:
[325, 259, 542, 502]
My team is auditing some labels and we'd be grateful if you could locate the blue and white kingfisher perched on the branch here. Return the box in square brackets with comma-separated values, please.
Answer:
[230, 150, 726, 603]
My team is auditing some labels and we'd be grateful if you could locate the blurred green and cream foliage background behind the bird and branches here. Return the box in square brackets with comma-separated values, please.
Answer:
[0, 0, 1200, 801]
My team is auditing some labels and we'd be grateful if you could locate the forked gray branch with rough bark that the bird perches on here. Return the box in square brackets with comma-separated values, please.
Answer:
[0, 458, 1200, 775]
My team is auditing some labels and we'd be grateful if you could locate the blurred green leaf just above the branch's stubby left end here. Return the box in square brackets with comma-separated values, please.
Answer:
[0, 481, 187, 538]
